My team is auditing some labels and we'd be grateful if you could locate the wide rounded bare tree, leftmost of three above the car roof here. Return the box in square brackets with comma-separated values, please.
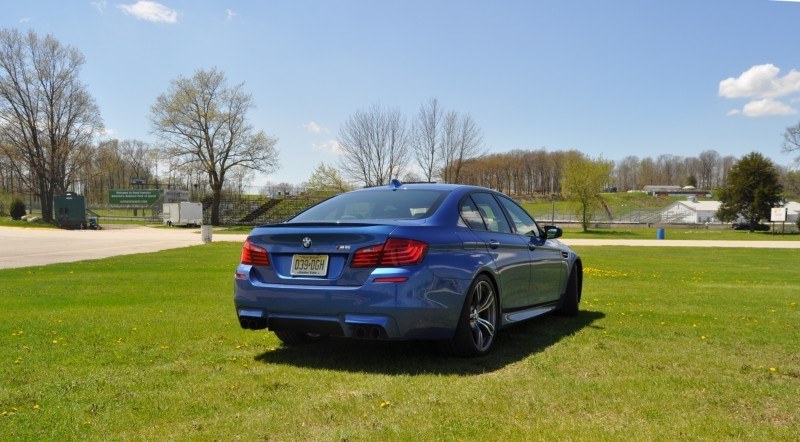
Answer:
[338, 105, 410, 186]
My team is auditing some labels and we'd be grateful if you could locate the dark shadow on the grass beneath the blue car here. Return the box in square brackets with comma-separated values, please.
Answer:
[255, 311, 605, 375]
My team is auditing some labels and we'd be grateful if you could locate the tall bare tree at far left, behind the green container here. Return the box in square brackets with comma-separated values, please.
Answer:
[0, 29, 103, 221]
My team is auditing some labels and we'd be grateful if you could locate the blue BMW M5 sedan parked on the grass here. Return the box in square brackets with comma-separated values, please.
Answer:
[234, 180, 583, 356]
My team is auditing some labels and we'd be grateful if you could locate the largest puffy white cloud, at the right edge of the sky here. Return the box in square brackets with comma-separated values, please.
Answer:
[719, 64, 800, 98]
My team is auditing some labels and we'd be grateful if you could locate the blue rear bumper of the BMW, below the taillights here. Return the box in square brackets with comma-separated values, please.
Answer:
[234, 266, 469, 339]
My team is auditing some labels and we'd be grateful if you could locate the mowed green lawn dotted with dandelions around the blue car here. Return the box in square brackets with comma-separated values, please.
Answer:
[0, 243, 800, 440]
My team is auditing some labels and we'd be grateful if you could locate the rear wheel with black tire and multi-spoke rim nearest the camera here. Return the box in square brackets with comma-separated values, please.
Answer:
[440, 275, 500, 358]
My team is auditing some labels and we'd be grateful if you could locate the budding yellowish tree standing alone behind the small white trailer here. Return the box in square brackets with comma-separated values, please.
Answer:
[150, 68, 278, 225]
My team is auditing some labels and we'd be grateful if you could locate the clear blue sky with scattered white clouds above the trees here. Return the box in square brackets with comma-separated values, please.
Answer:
[0, 0, 800, 184]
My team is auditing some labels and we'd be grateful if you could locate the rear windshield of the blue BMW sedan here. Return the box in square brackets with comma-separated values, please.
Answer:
[289, 189, 448, 223]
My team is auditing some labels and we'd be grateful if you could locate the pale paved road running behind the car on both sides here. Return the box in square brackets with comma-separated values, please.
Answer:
[0, 227, 800, 269]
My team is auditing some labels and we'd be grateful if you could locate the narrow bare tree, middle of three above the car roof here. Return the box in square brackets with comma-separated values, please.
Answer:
[411, 98, 443, 181]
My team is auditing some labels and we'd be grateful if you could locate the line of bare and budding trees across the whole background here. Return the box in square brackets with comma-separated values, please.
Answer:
[0, 29, 800, 224]
